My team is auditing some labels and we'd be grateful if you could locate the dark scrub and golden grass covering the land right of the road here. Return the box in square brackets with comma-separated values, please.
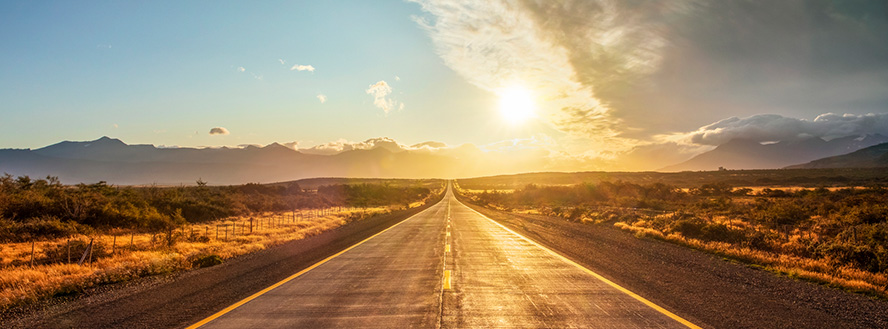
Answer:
[460, 181, 888, 298]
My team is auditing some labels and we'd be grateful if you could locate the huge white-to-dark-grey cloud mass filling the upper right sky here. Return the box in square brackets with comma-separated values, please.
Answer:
[411, 0, 888, 152]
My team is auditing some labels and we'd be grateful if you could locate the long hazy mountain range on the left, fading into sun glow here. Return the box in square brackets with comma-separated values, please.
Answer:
[0, 137, 539, 185]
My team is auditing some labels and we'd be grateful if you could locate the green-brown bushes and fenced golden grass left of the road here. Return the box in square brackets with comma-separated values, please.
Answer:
[0, 175, 443, 310]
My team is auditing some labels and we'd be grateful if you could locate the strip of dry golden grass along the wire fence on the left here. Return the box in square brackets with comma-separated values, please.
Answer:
[0, 207, 390, 310]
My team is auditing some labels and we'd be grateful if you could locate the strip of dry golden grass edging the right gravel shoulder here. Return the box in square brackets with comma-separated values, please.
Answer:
[614, 221, 888, 298]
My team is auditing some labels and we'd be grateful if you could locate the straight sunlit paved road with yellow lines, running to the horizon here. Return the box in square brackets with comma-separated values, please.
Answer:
[192, 186, 693, 328]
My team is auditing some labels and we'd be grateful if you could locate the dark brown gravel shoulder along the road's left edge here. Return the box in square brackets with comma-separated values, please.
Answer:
[0, 196, 436, 328]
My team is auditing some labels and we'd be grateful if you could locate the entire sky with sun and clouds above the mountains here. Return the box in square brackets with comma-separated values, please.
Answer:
[0, 0, 888, 170]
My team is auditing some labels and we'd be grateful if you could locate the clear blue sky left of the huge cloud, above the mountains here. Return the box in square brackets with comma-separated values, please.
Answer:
[0, 1, 548, 147]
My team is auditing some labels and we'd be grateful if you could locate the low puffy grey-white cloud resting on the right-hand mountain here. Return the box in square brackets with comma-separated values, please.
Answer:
[667, 113, 888, 145]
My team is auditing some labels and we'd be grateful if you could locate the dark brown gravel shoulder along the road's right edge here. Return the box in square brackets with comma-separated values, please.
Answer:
[460, 198, 888, 328]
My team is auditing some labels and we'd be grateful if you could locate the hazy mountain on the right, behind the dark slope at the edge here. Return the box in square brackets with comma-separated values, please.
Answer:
[659, 134, 888, 171]
